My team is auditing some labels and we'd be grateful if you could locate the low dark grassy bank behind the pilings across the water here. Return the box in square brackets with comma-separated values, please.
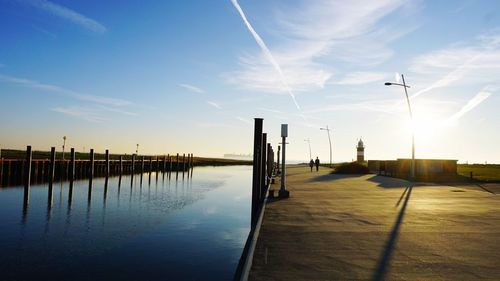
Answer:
[1, 149, 252, 166]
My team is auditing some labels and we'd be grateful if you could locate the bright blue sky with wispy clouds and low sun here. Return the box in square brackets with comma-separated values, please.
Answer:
[0, 0, 500, 163]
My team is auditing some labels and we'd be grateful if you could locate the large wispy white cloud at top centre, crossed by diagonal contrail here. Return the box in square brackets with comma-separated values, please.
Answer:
[224, 0, 420, 94]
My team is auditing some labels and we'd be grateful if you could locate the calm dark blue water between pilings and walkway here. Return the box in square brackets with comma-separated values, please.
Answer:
[0, 166, 251, 280]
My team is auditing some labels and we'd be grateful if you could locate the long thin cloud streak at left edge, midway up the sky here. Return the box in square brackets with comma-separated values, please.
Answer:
[0, 74, 132, 106]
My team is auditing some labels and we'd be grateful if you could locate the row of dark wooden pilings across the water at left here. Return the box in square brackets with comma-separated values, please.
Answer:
[0, 146, 193, 186]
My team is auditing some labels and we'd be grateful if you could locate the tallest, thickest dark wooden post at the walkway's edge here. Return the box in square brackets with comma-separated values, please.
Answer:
[250, 118, 264, 229]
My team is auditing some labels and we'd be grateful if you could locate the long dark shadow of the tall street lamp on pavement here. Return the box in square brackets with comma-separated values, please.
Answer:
[373, 185, 413, 280]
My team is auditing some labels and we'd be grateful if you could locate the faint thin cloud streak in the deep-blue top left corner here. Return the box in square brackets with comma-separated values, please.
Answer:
[22, 0, 107, 33]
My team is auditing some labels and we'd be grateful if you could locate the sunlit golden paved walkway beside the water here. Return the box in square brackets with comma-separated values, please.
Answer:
[250, 166, 500, 281]
